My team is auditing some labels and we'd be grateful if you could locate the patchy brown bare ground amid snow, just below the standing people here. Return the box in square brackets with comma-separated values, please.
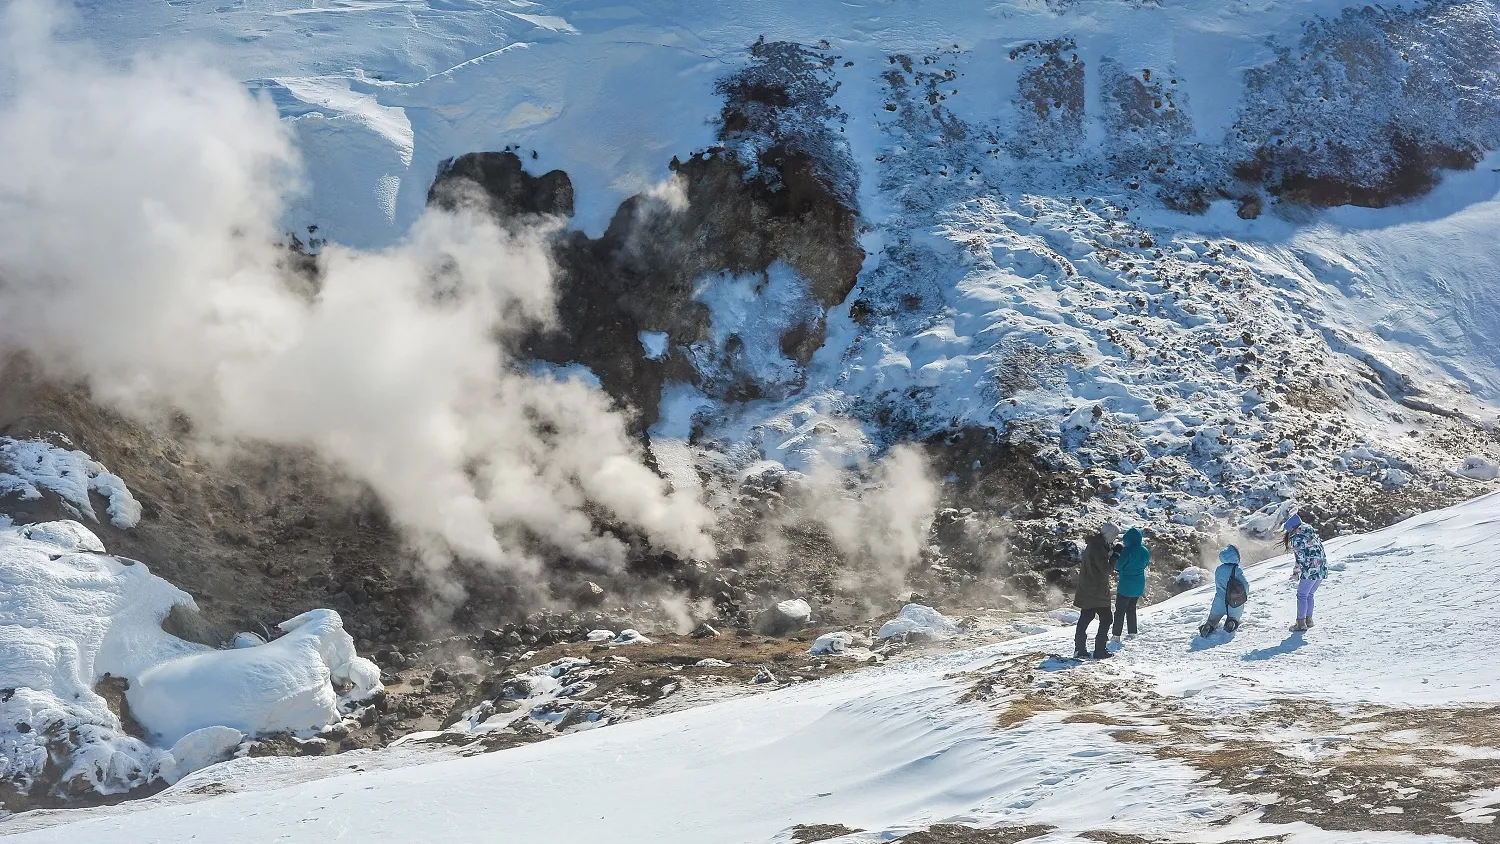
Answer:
[954, 654, 1500, 844]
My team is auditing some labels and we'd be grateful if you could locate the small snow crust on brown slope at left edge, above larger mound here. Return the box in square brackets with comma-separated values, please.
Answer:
[0, 436, 141, 529]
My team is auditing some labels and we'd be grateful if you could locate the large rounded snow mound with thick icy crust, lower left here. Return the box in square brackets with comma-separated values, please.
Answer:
[0, 522, 380, 798]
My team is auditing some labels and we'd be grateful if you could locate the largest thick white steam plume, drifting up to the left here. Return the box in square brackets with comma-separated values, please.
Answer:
[0, 3, 711, 587]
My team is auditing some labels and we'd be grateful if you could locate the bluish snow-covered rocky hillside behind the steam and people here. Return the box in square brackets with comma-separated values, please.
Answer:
[58, 0, 1500, 562]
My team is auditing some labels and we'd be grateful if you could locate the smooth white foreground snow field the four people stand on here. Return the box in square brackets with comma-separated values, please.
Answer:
[15, 495, 1500, 844]
